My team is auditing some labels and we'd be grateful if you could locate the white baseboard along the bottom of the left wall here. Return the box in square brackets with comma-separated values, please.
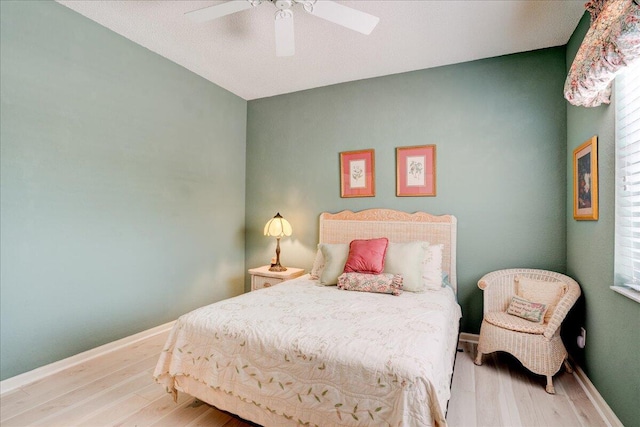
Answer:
[0, 320, 175, 395]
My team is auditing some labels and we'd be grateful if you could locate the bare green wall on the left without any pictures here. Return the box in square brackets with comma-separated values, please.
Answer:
[0, 0, 247, 379]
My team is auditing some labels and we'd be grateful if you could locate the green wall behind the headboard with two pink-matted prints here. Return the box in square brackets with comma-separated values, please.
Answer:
[245, 47, 567, 332]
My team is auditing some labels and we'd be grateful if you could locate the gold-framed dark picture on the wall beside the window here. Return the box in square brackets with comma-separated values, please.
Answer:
[573, 136, 598, 220]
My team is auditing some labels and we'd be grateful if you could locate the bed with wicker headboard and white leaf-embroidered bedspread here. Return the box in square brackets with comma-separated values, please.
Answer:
[154, 209, 461, 426]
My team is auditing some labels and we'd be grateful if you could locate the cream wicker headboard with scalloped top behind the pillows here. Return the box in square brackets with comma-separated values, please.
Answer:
[320, 209, 458, 292]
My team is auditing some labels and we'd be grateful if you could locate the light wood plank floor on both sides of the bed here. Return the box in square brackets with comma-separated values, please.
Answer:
[0, 332, 607, 427]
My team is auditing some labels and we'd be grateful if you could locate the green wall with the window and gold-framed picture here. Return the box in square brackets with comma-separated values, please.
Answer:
[566, 14, 640, 426]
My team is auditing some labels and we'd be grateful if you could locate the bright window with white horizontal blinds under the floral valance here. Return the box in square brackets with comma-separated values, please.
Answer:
[612, 64, 640, 302]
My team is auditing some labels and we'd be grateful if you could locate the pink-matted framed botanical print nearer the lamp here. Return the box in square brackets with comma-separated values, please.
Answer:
[340, 149, 376, 197]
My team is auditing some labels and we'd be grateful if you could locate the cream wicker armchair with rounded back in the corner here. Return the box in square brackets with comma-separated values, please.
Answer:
[475, 269, 580, 394]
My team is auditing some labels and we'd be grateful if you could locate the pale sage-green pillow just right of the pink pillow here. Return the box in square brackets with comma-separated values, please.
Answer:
[384, 242, 429, 292]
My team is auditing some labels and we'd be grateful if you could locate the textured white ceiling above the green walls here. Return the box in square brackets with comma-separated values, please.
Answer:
[58, 0, 585, 100]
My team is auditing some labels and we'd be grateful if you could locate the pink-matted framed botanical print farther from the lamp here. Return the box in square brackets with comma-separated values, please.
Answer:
[396, 145, 436, 197]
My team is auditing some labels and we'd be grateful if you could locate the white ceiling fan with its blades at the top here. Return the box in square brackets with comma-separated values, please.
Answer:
[185, 0, 380, 56]
